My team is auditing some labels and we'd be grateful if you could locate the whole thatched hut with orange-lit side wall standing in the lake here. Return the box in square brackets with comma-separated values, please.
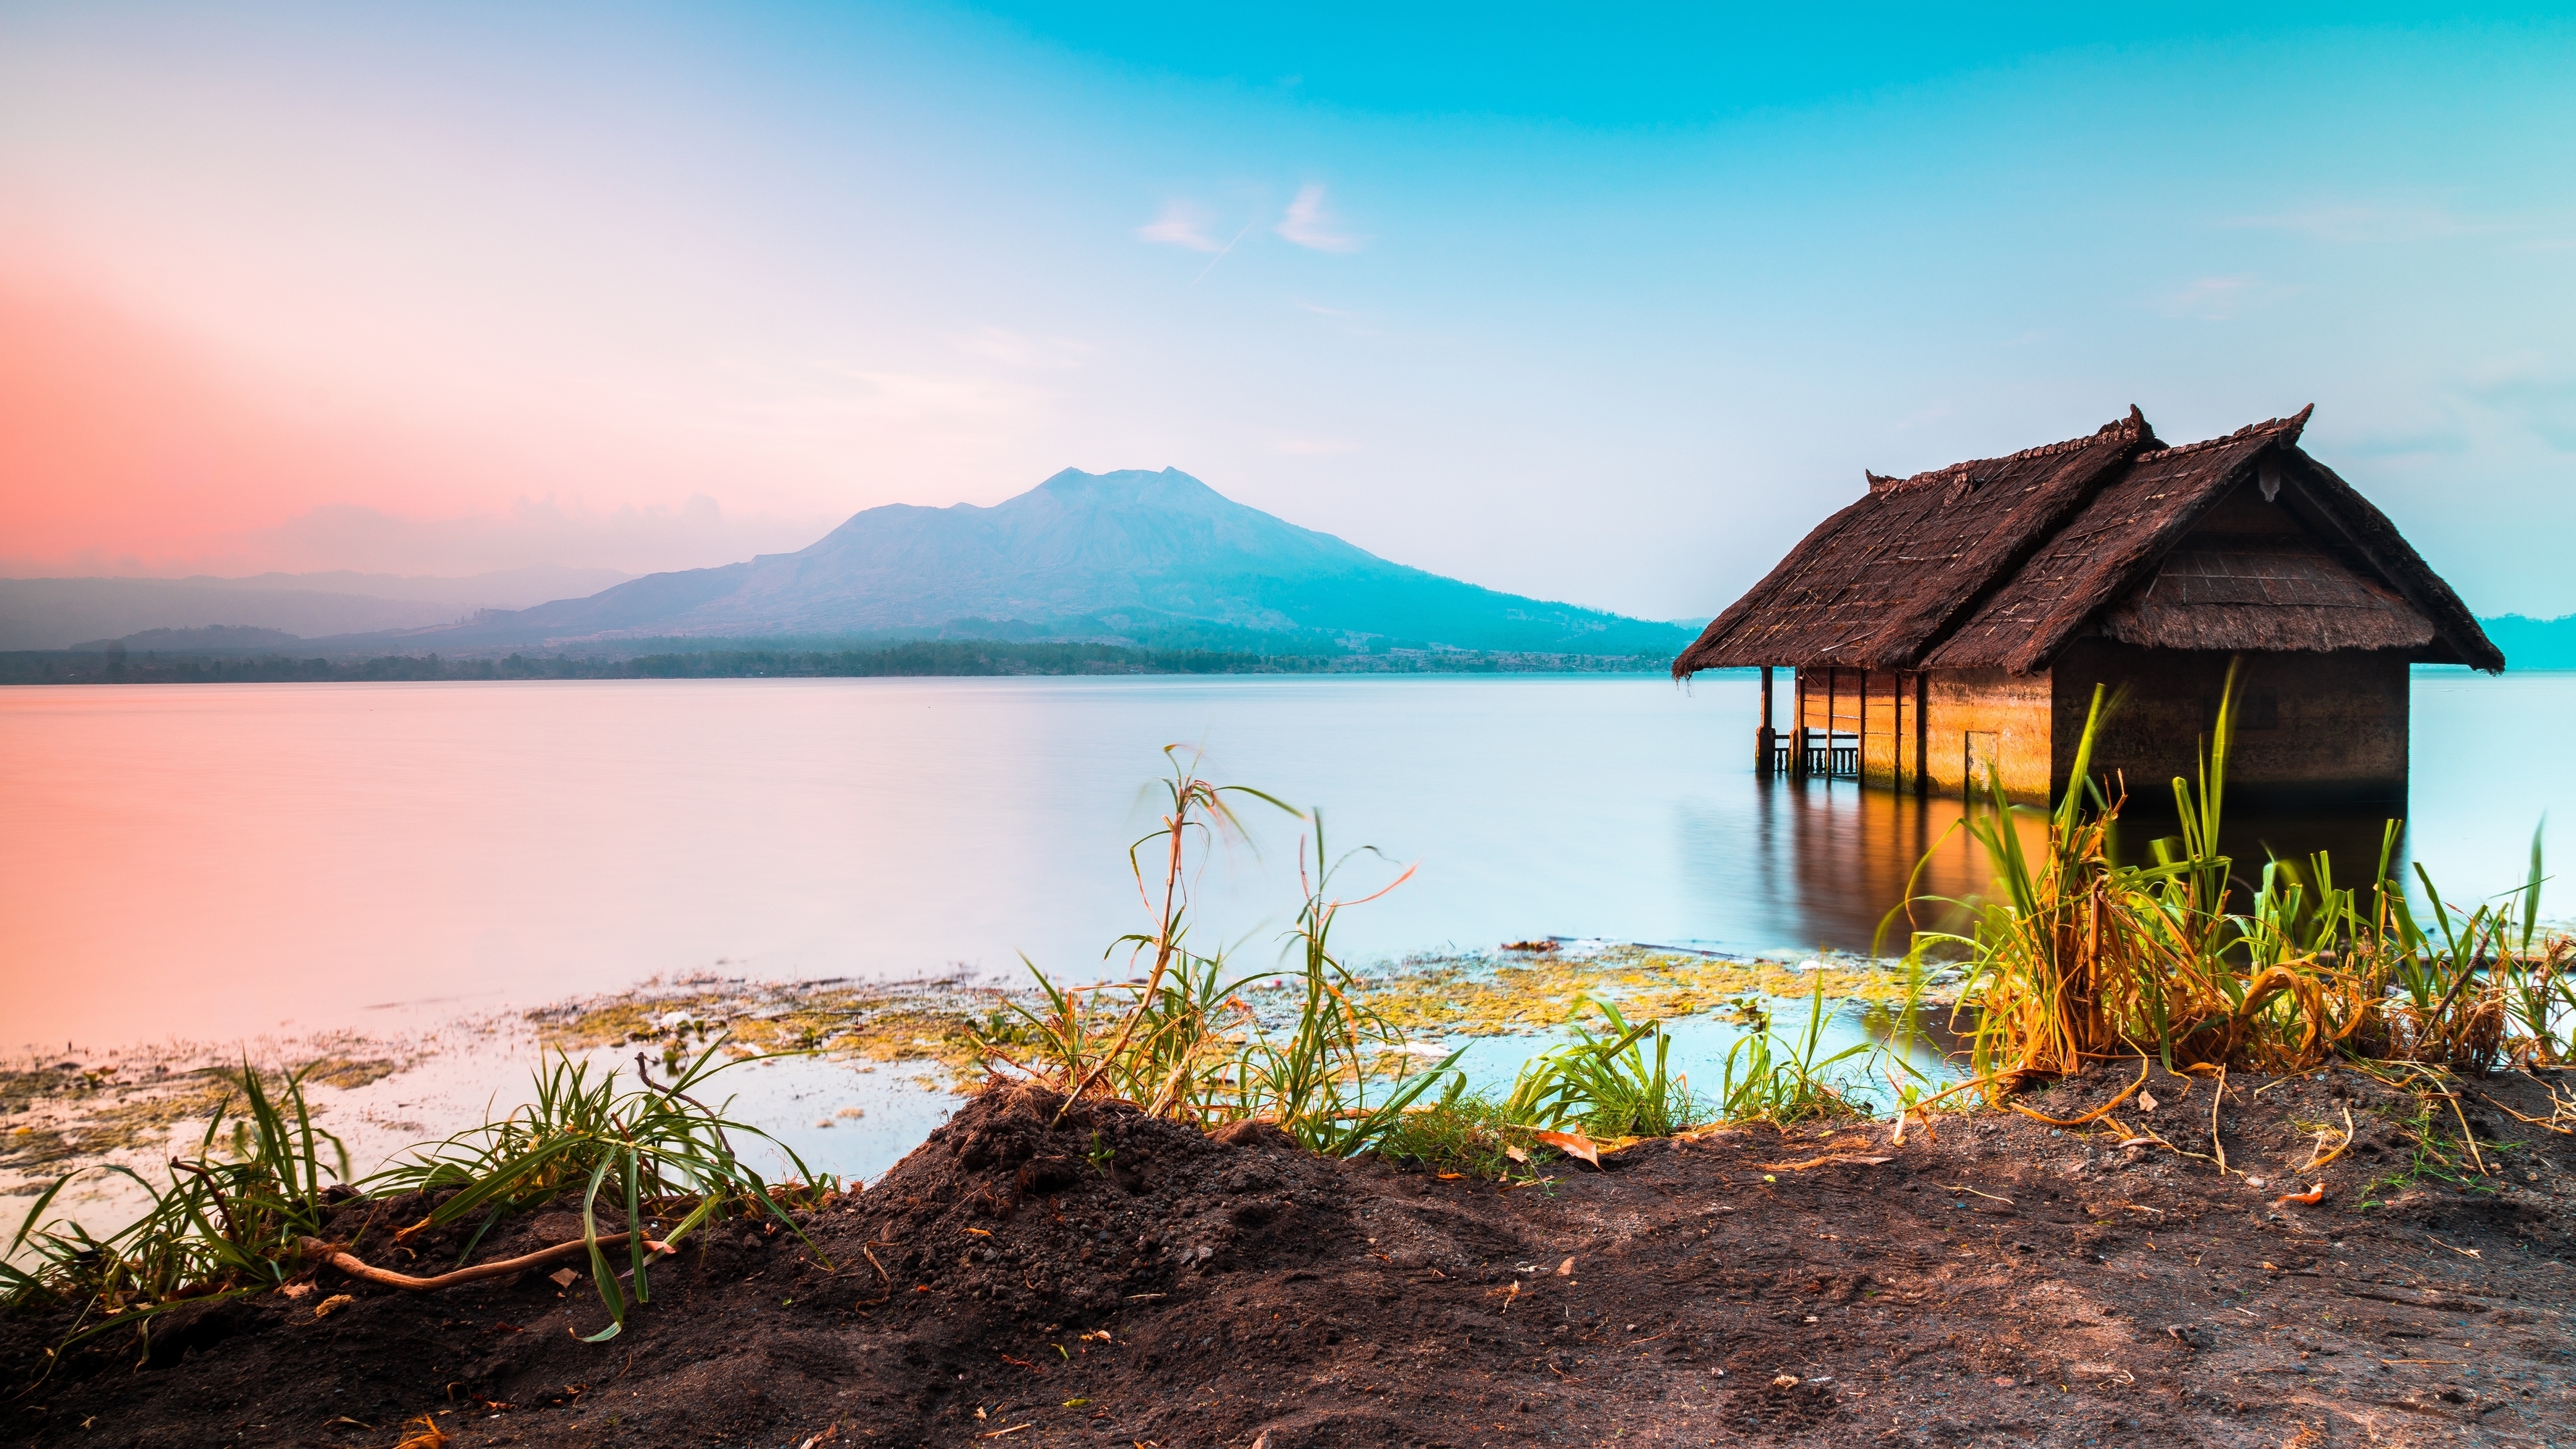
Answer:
[1672, 407, 2504, 802]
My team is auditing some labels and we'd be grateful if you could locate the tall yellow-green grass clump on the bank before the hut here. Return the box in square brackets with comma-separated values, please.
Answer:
[1891, 670, 2576, 1090]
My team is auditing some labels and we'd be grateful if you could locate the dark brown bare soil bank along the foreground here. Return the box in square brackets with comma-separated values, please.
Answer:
[0, 1072, 2576, 1449]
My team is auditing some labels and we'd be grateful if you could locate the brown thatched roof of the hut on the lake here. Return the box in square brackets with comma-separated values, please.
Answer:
[1672, 407, 2504, 675]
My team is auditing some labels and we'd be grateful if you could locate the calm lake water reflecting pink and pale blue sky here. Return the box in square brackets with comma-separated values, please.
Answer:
[0, 670, 2576, 1052]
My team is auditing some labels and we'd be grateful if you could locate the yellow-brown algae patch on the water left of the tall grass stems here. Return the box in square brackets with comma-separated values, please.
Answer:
[528, 977, 1005, 1090]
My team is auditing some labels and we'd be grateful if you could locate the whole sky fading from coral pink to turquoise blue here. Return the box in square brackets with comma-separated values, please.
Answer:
[0, 0, 2576, 619]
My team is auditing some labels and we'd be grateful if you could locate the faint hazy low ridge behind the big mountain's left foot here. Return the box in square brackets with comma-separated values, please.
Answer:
[0, 567, 629, 650]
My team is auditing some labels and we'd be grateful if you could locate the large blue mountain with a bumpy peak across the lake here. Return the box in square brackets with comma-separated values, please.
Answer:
[407, 469, 1690, 655]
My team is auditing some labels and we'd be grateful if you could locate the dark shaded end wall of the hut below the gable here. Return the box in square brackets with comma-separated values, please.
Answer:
[2048, 640, 2409, 804]
